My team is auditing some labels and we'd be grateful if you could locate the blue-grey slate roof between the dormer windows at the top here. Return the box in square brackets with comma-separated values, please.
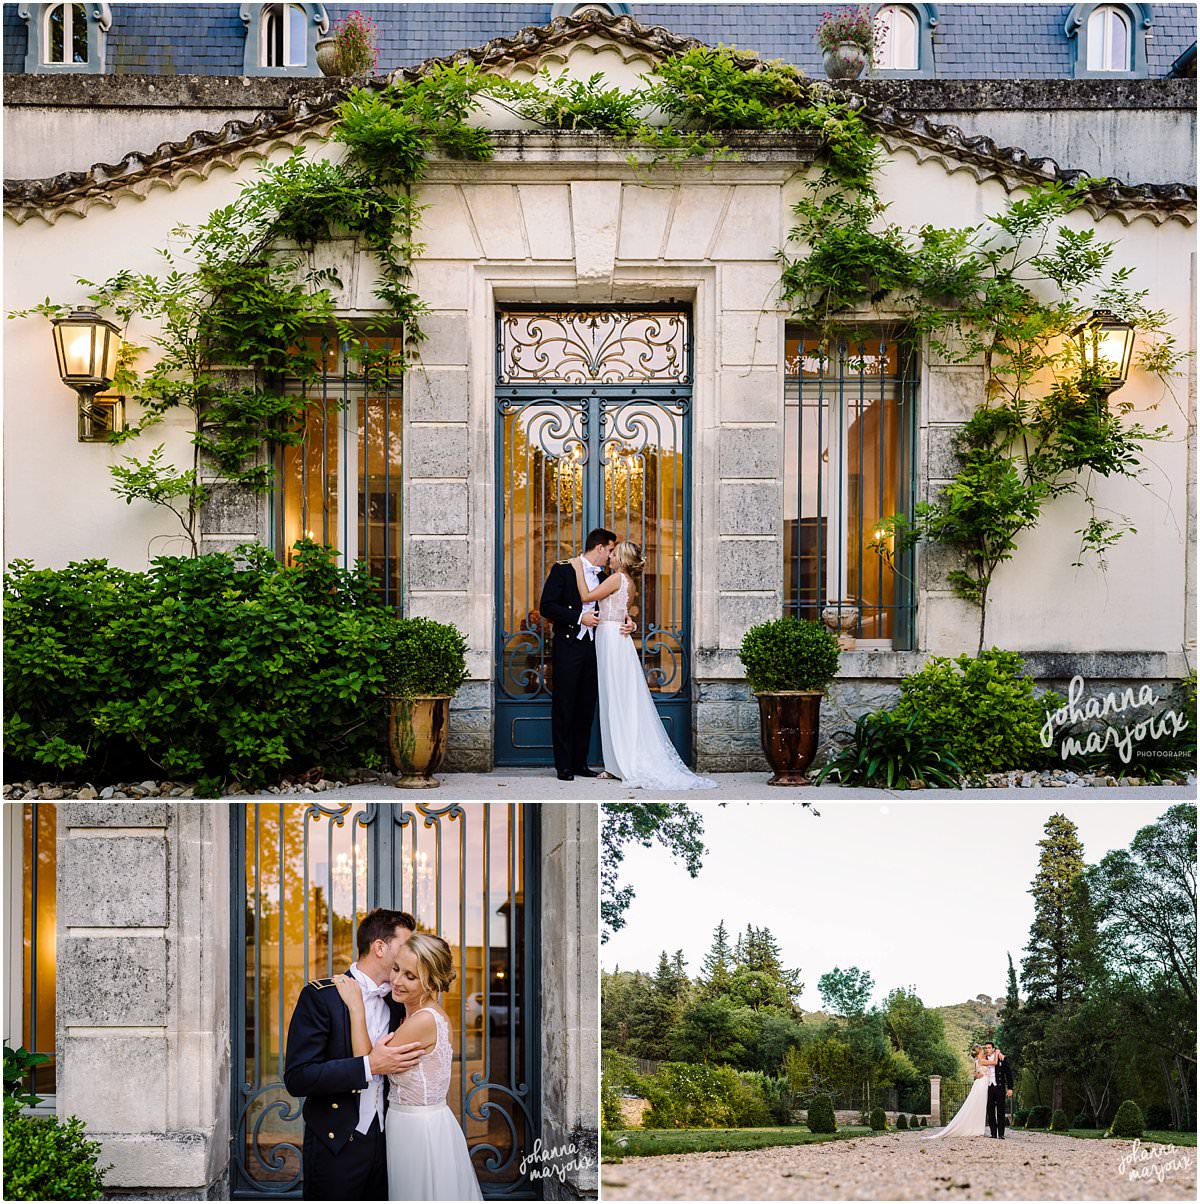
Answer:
[2, 2, 1196, 79]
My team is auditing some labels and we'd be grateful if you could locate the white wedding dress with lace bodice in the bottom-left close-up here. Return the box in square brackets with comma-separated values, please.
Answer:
[385, 1008, 483, 1200]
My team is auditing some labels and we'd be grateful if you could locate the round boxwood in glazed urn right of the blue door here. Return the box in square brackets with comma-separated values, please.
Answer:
[738, 619, 838, 786]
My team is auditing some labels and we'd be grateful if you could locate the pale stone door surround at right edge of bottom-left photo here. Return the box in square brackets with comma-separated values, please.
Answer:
[534, 803, 599, 1199]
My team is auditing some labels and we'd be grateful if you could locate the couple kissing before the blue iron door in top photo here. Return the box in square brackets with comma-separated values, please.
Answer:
[539, 527, 716, 790]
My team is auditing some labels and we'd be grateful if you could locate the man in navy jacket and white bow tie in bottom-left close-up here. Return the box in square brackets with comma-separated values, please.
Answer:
[283, 908, 421, 1200]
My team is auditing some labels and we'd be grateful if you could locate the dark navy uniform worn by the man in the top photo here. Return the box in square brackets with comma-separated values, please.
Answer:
[538, 560, 597, 773]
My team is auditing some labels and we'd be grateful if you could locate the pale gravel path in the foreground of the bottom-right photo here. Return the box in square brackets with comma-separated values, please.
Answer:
[601, 1132, 1196, 1200]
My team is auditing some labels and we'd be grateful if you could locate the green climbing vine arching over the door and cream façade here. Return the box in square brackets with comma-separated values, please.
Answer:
[11, 47, 1182, 606]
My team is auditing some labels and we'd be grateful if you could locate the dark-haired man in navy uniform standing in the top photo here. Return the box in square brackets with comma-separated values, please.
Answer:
[538, 527, 637, 781]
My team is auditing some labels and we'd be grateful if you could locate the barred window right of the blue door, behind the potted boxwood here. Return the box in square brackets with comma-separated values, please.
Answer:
[784, 326, 917, 649]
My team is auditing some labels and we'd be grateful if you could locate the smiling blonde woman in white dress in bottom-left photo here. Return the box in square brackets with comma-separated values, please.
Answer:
[333, 932, 483, 1200]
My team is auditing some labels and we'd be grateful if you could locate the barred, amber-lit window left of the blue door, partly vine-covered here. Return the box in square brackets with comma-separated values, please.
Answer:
[272, 335, 403, 610]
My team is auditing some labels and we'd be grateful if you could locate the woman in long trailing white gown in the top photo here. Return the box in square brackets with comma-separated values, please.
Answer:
[571, 541, 716, 790]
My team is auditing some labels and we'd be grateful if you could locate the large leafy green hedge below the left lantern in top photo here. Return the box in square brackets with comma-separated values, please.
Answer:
[4, 544, 435, 790]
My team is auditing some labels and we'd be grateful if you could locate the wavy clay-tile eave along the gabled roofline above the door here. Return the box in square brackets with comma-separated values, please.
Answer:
[5, 10, 1196, 224]
